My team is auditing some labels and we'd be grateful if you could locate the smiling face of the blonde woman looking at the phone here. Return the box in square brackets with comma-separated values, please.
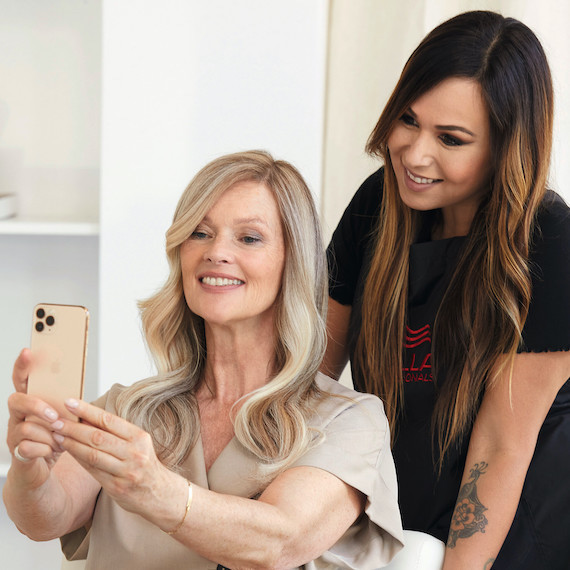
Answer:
[180, 181, 285, 334]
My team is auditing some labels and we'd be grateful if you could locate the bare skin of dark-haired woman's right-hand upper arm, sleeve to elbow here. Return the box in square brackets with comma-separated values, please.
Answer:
[471, 352, 570, 459]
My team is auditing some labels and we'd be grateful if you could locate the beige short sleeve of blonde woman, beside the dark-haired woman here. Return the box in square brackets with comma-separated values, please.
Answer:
[293, 379, 403, 569]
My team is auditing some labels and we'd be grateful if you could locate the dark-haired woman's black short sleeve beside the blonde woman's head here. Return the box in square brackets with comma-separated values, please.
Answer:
[327, 168, 384, 305]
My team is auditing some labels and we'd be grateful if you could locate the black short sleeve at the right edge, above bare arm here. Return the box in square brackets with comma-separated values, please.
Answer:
[522, 191, 570, 352]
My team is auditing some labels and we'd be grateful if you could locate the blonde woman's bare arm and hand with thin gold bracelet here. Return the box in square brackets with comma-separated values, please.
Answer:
[56, 401, 365, 569]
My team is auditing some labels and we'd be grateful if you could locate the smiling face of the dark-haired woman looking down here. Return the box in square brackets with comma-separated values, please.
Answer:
[388, 77, 491, 237]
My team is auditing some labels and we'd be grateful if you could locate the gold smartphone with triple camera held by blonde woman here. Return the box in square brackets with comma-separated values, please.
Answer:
[28, 303, 89, 420]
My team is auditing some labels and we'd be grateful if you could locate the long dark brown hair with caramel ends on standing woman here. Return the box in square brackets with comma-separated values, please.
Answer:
[355, 11, 553, 466]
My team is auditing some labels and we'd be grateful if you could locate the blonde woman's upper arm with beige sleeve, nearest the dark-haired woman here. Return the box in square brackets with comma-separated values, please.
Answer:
[255, 388, 402, 568]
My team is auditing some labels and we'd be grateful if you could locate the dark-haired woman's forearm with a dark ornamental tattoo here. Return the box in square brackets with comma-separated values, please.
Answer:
[443, 450, 532, 570]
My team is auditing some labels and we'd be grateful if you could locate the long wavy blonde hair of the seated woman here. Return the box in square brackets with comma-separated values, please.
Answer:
[117, 151, 327, 472]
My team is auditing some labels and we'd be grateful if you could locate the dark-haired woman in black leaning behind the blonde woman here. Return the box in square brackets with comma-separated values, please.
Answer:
[325, 12, 570, 570]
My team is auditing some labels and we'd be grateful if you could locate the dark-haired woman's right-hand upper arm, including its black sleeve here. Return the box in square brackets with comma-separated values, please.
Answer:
[471, 195, 570, 453]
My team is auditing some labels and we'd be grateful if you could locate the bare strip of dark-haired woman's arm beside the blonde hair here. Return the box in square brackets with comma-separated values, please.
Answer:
[321, 297, 352, 380]
